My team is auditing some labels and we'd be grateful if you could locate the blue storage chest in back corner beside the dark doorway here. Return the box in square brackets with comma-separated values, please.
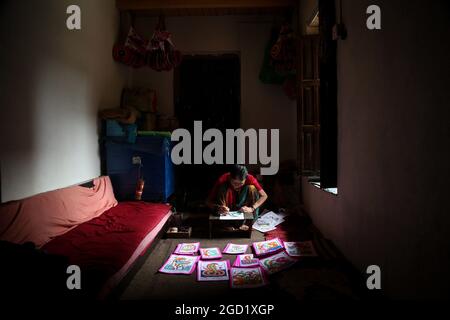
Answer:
[105, 136, 175, 202]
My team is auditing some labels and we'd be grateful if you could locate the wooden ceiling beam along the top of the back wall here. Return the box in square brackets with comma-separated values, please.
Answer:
[116, 0, 298, 11]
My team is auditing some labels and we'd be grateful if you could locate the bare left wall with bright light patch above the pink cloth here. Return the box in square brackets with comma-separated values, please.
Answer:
[0, 0, 127, 201]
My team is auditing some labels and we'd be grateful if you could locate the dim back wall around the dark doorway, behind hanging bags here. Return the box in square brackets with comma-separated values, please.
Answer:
[132, 16, 297, 161]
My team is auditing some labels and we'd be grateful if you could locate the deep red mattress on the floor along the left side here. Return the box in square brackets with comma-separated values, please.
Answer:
[42, 202, 171, 296]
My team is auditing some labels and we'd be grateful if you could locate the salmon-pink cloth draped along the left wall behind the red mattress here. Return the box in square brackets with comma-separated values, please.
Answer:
[0, 177, 117, 247]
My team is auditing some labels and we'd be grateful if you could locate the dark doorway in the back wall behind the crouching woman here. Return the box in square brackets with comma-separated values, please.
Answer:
[174, 54, 241, 209]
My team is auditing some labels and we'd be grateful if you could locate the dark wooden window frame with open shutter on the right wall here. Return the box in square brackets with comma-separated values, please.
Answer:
[297, 0, 338, 189]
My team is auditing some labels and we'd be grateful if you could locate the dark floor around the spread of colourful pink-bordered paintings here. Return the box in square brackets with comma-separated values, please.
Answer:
[118, 212, 368, 302]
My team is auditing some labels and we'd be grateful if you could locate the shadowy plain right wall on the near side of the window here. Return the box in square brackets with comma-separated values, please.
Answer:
[303, 0, 450, 298]
